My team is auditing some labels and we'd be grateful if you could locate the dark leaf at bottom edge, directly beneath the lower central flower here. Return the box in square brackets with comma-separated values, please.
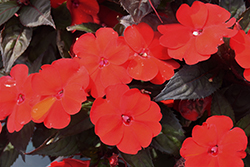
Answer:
[121, 149, 154, 167]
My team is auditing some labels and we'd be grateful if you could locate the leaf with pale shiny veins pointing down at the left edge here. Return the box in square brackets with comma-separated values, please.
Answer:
[0, 18, 32, 72]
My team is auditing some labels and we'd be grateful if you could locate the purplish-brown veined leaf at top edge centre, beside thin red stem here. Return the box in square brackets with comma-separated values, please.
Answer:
[120, 0, 161, 23]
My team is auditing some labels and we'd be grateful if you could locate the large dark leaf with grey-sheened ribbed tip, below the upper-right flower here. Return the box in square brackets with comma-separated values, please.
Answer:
[155, 59, 223, 101]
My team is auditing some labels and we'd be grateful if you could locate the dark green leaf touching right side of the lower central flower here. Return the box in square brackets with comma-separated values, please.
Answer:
[152, 105, 185, 156]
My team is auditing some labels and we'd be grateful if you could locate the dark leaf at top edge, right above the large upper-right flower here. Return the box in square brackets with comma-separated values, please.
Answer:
[219, 0, 246, 18]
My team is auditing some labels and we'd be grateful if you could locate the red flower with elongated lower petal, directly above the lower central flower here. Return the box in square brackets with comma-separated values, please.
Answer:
[73, 28, 132, 98]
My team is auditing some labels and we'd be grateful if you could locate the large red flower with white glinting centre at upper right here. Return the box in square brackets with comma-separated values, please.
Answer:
[158, 1, 237, 65]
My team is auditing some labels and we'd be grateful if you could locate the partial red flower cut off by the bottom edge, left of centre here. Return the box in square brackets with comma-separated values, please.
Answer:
[49, 158, 90, 167]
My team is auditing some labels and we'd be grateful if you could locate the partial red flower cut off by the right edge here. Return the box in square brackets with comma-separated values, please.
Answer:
[230, 30, 250, 81]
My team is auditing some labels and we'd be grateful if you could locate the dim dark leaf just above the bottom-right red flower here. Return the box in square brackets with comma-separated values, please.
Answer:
[211, 92, 235, 122]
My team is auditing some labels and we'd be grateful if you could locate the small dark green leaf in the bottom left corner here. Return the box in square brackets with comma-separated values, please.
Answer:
[0, 143, 19, 167]
